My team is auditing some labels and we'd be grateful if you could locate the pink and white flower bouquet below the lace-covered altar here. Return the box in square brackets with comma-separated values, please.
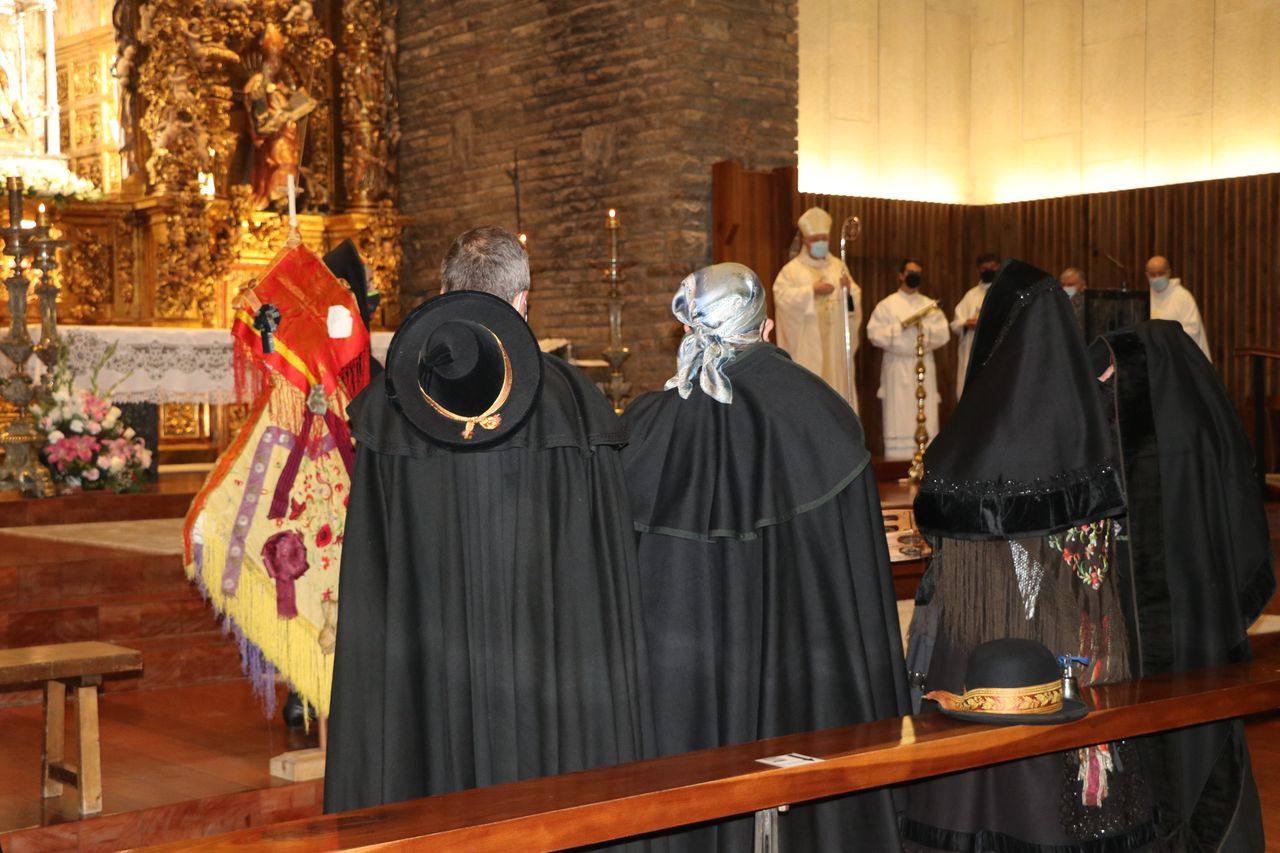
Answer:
[31, 346, 151, 492]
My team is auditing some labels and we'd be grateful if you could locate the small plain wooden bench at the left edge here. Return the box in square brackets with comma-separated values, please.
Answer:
[0, 643, 142, 817]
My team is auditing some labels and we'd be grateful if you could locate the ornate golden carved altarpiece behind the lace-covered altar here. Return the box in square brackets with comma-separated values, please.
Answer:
[0, 0, 402, 459]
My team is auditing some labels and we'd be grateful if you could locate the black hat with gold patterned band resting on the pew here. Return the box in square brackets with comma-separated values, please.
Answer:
[924, 639, 1089, 726]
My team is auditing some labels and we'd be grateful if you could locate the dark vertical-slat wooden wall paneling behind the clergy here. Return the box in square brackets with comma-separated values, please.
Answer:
[711, 162, 1280, 452]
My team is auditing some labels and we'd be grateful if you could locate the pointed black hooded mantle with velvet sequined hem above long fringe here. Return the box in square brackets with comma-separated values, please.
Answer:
[915, 260, 1124, 539]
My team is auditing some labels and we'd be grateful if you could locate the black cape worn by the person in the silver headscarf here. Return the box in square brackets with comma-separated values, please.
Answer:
[623, 343, 908, 850]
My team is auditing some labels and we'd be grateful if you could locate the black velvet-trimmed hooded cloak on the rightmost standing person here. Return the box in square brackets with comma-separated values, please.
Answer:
[1091, 320, 1275, 850]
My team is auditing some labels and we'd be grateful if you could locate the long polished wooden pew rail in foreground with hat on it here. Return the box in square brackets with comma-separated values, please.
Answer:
[140, 642, 1280, 853]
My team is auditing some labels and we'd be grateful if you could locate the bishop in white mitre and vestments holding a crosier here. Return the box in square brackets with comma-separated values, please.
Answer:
[773, 207, 863, 411]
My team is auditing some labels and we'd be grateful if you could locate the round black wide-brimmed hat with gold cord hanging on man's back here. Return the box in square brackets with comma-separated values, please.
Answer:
[387, 291, 543, 448]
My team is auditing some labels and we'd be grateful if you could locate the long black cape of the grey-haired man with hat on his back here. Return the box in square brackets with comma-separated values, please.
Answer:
[325, 356, 652, 812]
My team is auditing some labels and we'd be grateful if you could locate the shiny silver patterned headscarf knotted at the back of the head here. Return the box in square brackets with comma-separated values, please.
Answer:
[667, 264, 764, 403]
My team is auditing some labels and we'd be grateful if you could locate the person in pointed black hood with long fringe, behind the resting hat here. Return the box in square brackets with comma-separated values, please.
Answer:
[902, 261, 1158, 853]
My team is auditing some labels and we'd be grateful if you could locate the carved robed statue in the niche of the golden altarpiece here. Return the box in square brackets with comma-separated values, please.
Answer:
[244, 24, 316, 210]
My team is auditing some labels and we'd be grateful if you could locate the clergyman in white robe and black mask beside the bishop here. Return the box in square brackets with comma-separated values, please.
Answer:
[867, 260, 951, 460]
